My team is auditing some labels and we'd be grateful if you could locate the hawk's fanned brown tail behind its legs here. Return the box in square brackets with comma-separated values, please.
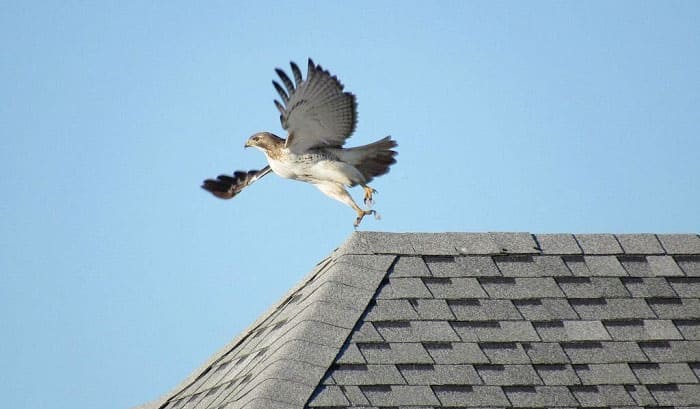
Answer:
[343, 136, 398, 183]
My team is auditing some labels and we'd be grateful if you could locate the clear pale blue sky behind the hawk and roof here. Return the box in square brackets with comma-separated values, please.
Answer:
[0, 1, 700, 408]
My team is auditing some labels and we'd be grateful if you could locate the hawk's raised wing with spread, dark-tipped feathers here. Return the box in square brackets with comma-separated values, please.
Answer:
[272, 58, 357, 153]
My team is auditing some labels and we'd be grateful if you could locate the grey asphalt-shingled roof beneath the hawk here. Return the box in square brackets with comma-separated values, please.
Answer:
[137, 232, 700, 409]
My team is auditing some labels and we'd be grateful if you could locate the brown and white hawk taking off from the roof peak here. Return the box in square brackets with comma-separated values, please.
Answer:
[202, 58, 398, 227]
